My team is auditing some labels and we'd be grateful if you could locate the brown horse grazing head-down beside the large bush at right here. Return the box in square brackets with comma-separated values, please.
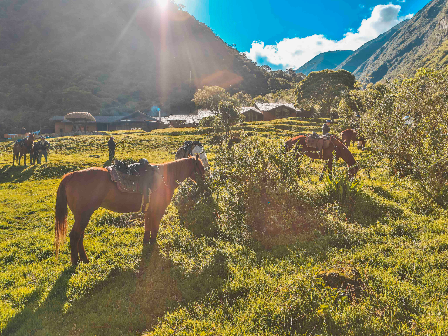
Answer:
[285, 135, 359, 180]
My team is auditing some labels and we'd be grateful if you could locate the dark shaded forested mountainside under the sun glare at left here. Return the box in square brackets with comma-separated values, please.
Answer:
[0, 0, 292, 131]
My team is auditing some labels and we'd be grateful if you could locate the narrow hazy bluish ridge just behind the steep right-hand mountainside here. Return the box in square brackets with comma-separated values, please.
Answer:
[336, 20, 407, 72]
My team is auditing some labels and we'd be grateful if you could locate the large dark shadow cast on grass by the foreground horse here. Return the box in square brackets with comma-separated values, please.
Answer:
[2, 245, 181, 335]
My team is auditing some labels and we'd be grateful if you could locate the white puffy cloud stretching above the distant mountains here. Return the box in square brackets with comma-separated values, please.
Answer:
[245, 4, 413, 69]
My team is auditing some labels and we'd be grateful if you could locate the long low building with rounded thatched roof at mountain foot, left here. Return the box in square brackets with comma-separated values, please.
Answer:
[50, 112, 160, 134]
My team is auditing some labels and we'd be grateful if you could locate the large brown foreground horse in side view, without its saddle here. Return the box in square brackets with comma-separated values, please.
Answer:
[55, 156, 205, 265]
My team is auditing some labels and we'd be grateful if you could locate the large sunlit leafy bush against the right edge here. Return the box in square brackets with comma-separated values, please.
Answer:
[361, 69, 448, 206]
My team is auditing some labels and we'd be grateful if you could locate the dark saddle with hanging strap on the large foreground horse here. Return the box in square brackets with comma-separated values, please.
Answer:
[106, 159, 163, 211]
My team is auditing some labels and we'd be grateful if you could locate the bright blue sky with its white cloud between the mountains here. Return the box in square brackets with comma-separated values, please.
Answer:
[175, 0, 430, 70]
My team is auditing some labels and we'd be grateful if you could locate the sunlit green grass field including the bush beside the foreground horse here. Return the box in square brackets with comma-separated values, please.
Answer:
[0, 118, 448, 335]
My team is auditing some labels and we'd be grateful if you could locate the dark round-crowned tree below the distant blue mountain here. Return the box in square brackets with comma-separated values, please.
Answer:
[296, 70, 356, 116]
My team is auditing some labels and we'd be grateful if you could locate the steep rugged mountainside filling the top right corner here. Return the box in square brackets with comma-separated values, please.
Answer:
[353, 0, 448, 83]
